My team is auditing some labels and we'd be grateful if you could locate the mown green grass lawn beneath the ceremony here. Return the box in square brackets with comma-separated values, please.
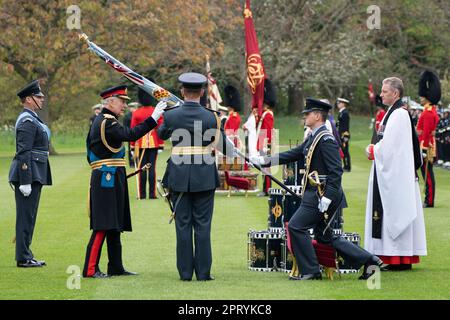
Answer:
[0, 117, 450, 300]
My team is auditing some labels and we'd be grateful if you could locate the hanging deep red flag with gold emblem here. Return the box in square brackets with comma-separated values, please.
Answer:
[244, 0, 266, 115]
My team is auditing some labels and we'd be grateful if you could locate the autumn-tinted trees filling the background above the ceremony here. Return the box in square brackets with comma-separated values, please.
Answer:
[0, 0, 450, 127]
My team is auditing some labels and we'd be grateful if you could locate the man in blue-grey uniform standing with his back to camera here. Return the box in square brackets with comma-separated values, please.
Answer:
[158, 73, 233, 281]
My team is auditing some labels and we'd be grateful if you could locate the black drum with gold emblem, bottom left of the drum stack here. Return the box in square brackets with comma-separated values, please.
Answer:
[247, 230, 282, 272]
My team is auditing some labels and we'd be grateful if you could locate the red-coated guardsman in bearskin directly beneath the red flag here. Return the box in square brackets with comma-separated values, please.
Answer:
[256, 79, 277, 196]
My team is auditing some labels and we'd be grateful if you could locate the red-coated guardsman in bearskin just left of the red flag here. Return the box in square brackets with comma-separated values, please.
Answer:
[224, 85, 241, 148]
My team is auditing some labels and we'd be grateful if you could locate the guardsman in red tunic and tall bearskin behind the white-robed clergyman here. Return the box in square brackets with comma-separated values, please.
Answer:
[416, 70, 441, 208]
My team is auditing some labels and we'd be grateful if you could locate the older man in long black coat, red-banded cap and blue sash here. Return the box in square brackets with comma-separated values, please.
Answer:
[83, 85, 166, 278]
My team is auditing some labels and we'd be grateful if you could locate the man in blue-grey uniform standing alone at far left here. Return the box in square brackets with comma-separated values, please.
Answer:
[9, 80, 52, 268]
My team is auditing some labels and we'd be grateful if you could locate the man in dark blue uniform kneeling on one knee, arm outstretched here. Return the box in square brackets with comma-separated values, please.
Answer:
[251, 98, 382, 280]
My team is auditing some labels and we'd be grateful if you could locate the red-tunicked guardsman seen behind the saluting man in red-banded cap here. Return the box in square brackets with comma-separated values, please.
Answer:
[131, 88, 164, 199]
